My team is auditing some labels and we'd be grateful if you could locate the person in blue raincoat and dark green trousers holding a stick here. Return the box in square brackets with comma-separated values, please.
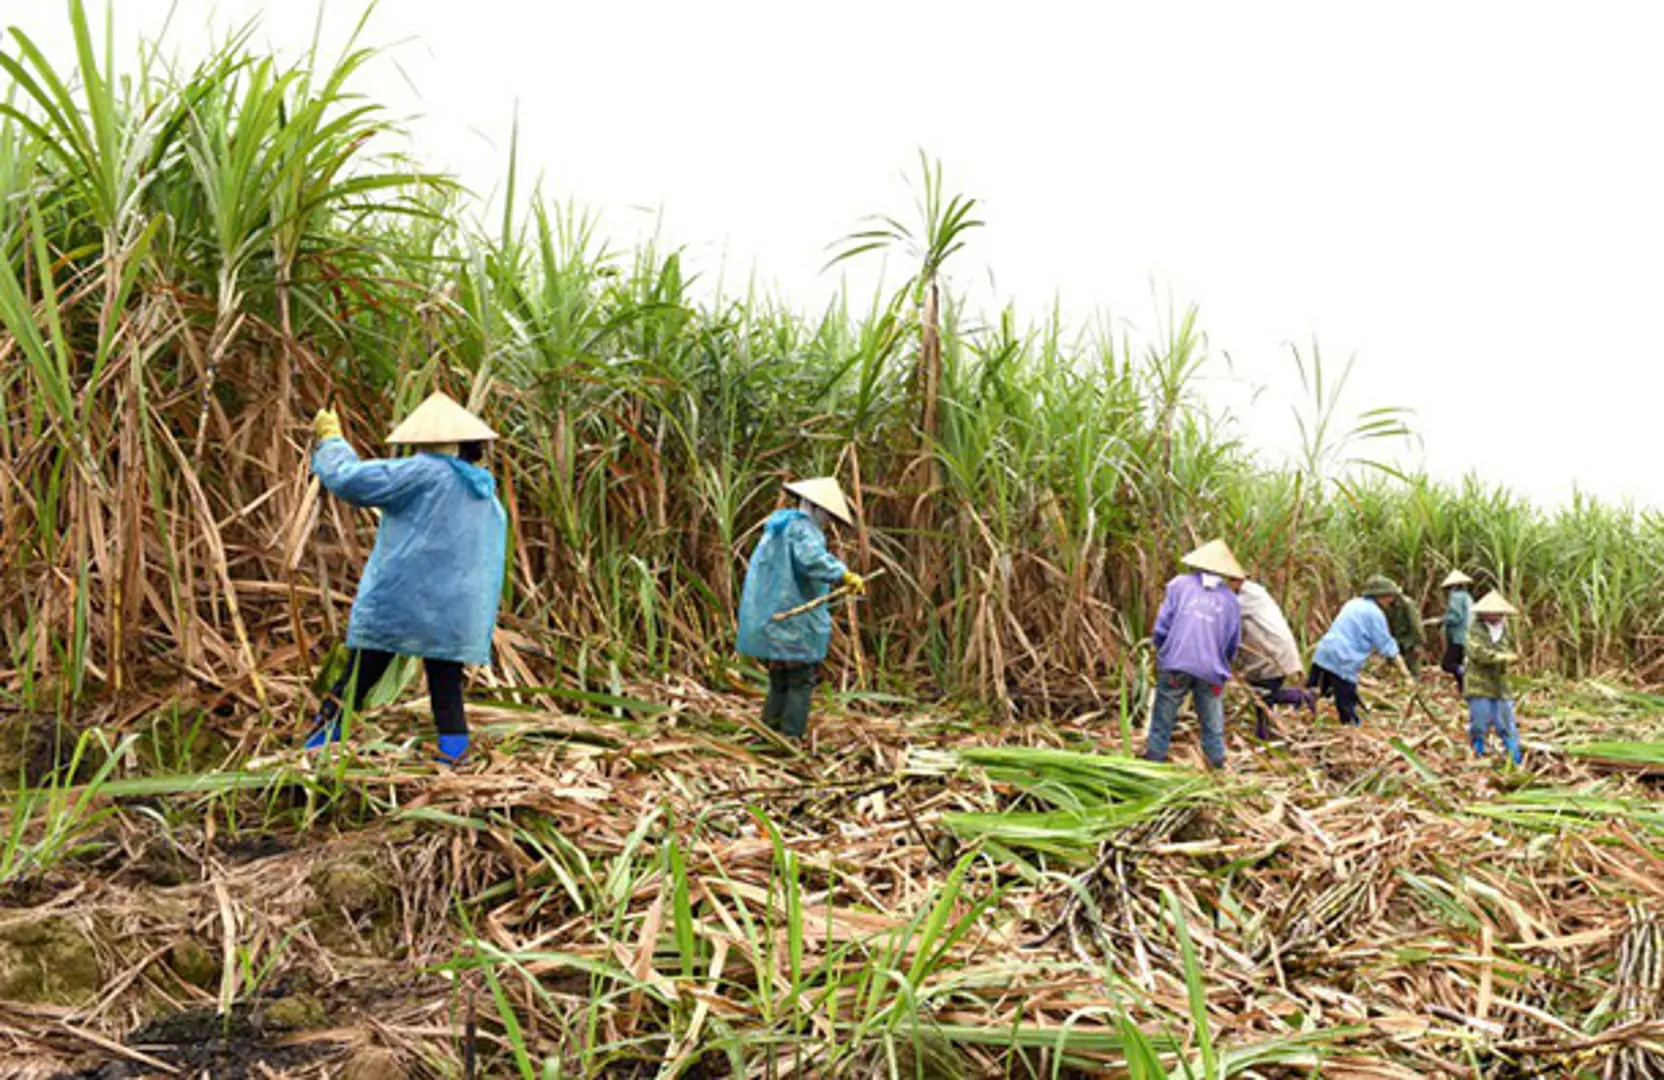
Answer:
[737, 476, 867, 739]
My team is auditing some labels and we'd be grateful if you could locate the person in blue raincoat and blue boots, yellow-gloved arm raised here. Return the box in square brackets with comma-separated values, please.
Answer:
[306, 393, 508, 765]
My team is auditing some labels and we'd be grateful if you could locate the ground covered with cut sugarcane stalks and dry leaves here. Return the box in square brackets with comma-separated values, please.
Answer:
[0, 672, 1664, 1077]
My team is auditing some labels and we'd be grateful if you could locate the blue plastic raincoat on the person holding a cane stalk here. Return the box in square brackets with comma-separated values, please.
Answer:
[739, 509, 849, 664]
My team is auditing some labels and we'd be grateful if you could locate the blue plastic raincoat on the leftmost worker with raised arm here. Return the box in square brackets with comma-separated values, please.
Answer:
[313, 439, 508, 664]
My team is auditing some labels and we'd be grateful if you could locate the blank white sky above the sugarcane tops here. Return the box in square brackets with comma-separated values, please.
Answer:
[13, 0, 1664, 506]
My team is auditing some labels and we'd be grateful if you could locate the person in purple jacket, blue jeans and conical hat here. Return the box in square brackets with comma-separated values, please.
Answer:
[1145, 541, 1248, 769]
